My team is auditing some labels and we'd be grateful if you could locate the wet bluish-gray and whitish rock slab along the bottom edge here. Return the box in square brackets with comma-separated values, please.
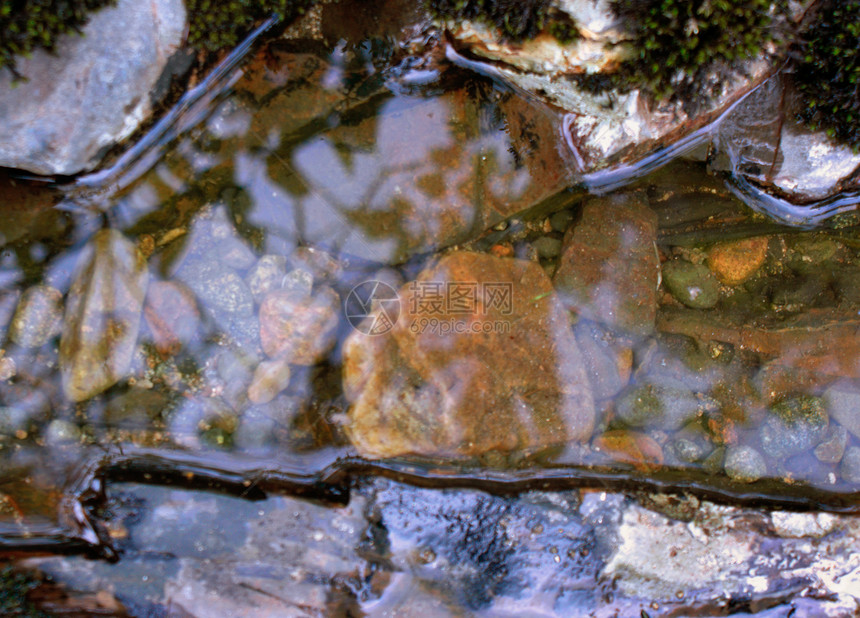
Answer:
[20, 481, 860, 617]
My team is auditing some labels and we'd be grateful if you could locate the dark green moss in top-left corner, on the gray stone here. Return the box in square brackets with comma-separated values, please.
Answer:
[0, 0, 116, 77]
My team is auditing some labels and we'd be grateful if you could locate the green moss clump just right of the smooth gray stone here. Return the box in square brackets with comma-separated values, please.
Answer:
[187, 0, 313, 52]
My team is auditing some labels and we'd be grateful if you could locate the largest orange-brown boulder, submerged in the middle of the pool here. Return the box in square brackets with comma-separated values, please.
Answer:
[344, 252, 594, 458]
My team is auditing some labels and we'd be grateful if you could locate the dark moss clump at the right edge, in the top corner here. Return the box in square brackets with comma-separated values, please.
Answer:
[795, 0, 860, 150]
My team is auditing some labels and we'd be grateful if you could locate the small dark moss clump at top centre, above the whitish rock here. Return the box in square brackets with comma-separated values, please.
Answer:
[425, 0, 579, 44]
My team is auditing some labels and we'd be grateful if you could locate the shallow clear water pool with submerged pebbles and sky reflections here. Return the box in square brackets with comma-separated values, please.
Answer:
[0, 27, 860, 547]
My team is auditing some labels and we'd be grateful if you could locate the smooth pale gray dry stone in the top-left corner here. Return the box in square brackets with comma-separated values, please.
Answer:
[0, 0, 186, 174]
